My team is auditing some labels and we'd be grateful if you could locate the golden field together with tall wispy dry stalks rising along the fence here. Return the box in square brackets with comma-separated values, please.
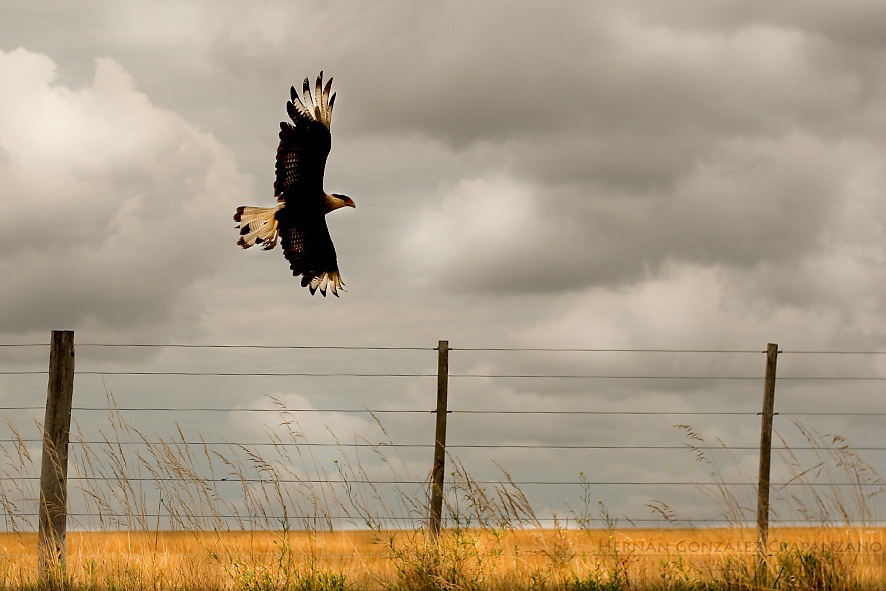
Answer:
[0, 402, 886, 591]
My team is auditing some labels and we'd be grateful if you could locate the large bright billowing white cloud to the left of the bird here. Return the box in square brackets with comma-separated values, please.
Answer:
[0, 49, 252, 334]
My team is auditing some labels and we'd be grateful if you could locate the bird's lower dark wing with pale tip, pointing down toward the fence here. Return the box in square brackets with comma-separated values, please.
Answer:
[280, 213, 344, 297]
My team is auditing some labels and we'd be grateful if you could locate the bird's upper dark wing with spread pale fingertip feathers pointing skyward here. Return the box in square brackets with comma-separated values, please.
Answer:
[274, 72, 335, 202]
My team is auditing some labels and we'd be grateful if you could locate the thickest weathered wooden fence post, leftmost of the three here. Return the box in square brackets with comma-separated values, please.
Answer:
[38, 330, 74, 579]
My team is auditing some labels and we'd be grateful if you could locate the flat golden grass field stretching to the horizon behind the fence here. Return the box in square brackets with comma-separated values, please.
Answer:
[0, 528, 886, 591]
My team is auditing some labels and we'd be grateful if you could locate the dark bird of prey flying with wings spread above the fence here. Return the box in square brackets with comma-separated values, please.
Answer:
[234, 72, 356, 297]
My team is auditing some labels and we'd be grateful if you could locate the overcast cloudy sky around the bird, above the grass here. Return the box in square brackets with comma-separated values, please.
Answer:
[0, 0, 886, 532]
